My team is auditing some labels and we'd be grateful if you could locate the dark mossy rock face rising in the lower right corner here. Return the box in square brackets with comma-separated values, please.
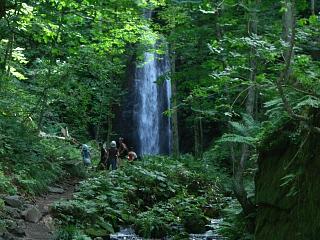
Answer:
[255, 123, 320, 240]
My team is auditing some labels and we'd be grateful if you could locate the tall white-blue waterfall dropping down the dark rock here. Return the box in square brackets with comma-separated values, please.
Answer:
[134, 46, 171, 155]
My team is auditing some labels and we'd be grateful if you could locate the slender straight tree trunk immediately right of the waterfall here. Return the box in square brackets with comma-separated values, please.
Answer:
[170, 52, 179, 157]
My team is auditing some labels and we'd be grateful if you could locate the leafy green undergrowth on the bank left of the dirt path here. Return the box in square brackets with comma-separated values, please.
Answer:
[0, 120, 84, 196]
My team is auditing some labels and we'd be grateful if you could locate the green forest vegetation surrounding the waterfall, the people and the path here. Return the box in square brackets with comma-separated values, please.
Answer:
[0, 0, 320, 240]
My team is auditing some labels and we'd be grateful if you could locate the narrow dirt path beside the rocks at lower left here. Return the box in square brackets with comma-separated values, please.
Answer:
[23, 180, 78, 240]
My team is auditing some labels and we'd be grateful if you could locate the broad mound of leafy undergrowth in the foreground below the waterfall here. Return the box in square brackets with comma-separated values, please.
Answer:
[52, 156, 228, 239]
